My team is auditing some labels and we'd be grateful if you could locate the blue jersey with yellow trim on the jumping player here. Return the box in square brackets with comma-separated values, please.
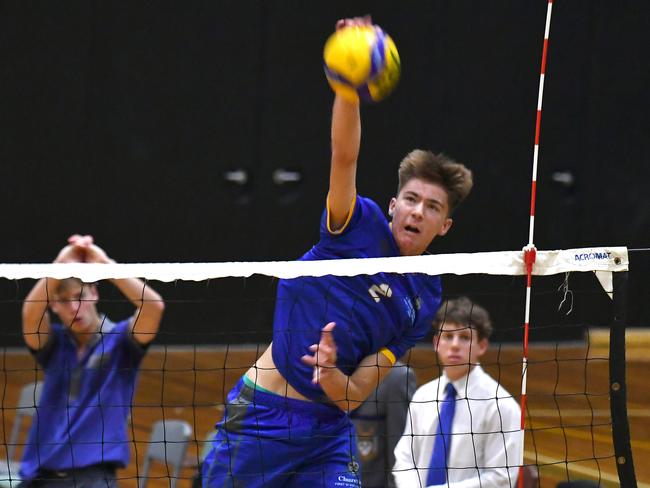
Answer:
[273, 196, 442, 402]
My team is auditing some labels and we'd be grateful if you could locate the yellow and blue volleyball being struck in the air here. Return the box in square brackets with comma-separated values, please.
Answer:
[323, 25, 400, 102]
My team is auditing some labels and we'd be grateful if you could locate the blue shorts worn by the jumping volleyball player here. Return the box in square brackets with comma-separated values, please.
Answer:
[202, 379, 361, 488]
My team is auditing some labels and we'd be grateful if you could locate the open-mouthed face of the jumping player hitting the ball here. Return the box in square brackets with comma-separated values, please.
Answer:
[389, 178, 452, 256]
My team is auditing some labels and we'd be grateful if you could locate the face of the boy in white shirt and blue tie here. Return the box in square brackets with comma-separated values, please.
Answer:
[433, 323, 488, 381]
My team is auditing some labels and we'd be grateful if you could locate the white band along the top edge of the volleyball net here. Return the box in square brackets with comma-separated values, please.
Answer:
[0, 247, 629, 283]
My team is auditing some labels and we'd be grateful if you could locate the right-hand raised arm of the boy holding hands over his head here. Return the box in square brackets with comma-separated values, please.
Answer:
[71, 236, 165, 345]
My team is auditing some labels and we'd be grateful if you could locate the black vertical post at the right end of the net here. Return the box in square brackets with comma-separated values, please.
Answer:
[609, 272, 637, 488]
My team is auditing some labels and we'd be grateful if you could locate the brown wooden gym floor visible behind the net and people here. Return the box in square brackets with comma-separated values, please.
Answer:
[0, 341, 650, 488]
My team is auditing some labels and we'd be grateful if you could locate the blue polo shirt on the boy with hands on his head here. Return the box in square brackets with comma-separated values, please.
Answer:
[20, 318, 146, 480]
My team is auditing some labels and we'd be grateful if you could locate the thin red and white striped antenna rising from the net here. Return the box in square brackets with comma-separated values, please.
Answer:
[518, 0, 553, 488]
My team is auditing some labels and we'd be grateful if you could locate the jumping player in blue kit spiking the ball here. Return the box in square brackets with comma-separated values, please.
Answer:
[203, 15, 472, 488]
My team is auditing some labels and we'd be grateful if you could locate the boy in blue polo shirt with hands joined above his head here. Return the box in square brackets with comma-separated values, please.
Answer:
[20, 235, 164, 488]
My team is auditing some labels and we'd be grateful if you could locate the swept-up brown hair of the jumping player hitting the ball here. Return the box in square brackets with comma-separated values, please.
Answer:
[397, 149, 474, 213]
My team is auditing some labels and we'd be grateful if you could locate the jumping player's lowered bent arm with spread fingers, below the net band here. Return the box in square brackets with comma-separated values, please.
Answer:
[302, 322, 393, 412]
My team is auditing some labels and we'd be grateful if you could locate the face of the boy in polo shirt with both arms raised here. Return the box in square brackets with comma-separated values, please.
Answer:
[52, 284, 99, 333]
